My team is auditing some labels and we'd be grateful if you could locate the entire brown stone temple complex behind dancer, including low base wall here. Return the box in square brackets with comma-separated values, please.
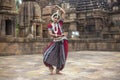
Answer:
[0, 0, 120, 55]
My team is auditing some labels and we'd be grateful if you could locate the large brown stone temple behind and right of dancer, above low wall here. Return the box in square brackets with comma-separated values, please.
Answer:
[42, 0, 120, 39]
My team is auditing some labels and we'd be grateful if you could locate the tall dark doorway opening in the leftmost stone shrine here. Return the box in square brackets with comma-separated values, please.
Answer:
[5, 20, 12, 35]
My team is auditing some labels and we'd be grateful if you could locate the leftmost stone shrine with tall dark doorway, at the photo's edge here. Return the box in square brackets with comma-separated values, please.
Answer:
[0, 0, 17, 37]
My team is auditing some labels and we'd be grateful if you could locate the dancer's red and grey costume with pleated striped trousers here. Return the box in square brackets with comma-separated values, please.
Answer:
[43, 21, 68, 70]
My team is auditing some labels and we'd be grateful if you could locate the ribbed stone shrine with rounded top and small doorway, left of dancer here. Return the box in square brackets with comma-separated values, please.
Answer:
[18, 0, 43, 38]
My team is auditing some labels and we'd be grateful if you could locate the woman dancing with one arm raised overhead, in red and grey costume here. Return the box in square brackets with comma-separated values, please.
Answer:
[43, 5, 68, 74]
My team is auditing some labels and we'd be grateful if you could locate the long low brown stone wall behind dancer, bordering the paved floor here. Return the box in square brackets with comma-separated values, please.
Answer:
[0, 38, 120, 55]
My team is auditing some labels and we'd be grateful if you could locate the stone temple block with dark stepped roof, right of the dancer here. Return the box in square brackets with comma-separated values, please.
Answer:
[76, 0, 108, 38]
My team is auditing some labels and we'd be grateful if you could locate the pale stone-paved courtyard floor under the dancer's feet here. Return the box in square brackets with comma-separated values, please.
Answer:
[0, 51, 120, 80]
